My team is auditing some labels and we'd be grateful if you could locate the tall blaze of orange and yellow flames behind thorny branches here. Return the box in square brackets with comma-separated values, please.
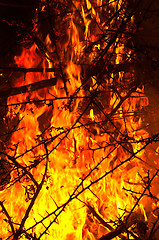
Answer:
[0, 0, 158, 240]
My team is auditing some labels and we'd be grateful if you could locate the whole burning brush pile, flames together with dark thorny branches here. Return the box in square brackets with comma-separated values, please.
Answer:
[0, 0, 159, 240]
